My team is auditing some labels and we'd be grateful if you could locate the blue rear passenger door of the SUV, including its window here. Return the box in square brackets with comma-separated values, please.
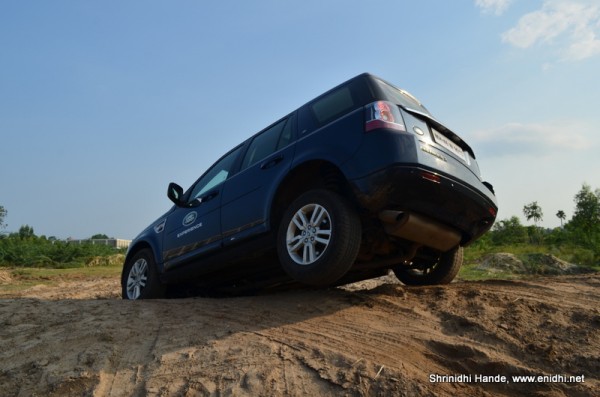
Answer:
[221, 116, 295, 245]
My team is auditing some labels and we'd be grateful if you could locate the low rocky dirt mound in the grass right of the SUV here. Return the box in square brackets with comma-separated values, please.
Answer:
[477, 253, 582, 275]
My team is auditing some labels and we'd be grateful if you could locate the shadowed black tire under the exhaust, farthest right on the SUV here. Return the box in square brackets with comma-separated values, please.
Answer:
[393, 247, 463, 285]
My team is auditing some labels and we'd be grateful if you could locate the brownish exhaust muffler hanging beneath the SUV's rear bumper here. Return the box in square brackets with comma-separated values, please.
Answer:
[379, 210, 462, 252]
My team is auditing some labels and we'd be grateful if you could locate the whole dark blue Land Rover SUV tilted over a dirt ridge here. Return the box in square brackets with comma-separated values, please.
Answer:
[121, 73, 498, 299]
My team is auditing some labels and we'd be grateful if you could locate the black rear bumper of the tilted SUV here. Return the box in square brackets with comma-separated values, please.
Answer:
[350, 165, 498, 245]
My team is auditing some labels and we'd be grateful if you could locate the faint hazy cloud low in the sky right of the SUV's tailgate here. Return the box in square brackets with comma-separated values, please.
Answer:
[470, 121, 593, 157]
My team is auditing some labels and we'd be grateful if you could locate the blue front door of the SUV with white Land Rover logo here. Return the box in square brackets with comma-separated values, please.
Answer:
[163, 146, 242, 270]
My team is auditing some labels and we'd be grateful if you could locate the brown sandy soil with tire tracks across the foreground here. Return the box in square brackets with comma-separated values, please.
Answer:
[0, 275, 600, 396]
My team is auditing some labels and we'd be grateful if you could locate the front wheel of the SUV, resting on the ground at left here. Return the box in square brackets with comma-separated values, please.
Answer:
[121, 248, 166, 300]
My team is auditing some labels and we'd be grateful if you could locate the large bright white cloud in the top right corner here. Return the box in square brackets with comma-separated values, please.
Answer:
[502, 0, 600, 61]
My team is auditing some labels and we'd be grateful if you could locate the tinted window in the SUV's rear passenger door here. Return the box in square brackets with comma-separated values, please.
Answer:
[242, 116, 292, 169]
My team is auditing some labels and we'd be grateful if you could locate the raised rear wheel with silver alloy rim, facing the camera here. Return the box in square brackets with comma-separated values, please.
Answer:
[277, 189, 362, 287]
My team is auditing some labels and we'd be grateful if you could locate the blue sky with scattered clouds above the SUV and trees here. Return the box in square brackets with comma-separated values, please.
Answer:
[0, 0, 600, 238]
